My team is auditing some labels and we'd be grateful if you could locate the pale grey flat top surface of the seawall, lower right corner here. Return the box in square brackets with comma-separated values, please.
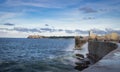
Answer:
[82, 43, 120, 72]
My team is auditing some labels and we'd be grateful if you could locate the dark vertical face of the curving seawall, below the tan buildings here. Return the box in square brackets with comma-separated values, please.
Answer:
[88, 41, 117, 63]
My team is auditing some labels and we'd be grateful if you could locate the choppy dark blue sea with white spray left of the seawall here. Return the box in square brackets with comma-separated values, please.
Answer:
[0, 38, 81, 72]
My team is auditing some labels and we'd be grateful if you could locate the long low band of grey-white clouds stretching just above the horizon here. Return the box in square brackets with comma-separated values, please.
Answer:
[0, 27, 120, 35]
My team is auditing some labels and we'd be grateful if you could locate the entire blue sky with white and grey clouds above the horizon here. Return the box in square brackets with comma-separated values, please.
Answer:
[0, 0, 120, 38]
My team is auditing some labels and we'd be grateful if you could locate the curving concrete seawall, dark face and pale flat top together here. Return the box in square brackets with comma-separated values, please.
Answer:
[82, 41, 120, 72]
